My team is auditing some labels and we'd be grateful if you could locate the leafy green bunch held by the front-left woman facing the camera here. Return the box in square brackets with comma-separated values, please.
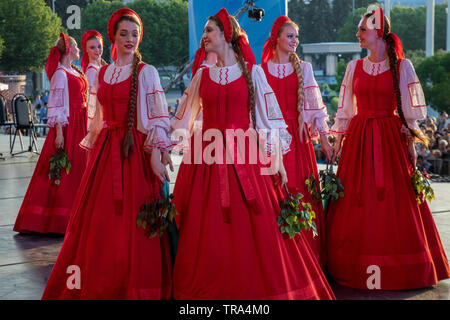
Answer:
[136, 194, 177, 238]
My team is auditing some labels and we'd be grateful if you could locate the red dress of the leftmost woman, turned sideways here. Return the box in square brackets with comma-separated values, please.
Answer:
[14, 68, 88, 234]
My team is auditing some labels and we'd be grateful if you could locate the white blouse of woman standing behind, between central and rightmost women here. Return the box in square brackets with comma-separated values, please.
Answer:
[267, 60, 329, 137]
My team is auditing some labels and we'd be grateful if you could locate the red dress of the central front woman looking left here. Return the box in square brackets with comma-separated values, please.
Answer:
[174, 68, 334, 299]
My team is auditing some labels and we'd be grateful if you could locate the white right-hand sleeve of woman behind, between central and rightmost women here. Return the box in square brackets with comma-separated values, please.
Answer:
[302, 62, 329, 137]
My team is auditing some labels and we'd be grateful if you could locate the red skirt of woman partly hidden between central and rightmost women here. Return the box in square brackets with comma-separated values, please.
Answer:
[283, 119, 326, 268]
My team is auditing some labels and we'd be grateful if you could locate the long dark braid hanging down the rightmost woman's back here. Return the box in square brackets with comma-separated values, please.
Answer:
[363, 13, 428, 146]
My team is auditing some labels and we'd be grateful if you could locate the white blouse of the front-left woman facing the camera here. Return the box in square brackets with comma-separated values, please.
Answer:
[80, 62, 174, 151]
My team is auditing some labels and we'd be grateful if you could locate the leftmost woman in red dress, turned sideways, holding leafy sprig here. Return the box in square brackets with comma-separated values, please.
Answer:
[14, 33, 88, 234]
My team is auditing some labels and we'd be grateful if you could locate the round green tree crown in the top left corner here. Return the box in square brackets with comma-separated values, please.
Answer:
[0, 0, 63, 72]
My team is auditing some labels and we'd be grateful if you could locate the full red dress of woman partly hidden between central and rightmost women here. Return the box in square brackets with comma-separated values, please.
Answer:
[261, 63, 326, 267]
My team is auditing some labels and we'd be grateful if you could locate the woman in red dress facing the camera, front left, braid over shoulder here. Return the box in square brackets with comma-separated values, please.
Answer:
[42, 8, 172, 299]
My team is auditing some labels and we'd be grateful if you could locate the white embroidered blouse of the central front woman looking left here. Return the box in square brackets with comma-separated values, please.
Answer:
[171, 63, 292, 154]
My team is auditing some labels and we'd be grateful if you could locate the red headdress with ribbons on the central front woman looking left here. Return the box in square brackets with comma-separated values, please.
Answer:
[192, 8, 256, 77]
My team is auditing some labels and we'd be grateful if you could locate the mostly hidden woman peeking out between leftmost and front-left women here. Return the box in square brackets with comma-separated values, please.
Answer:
[81, 30, 106, 129]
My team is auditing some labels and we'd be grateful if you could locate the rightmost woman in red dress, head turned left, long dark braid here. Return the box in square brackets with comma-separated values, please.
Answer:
[327, 8, 450, 290]
